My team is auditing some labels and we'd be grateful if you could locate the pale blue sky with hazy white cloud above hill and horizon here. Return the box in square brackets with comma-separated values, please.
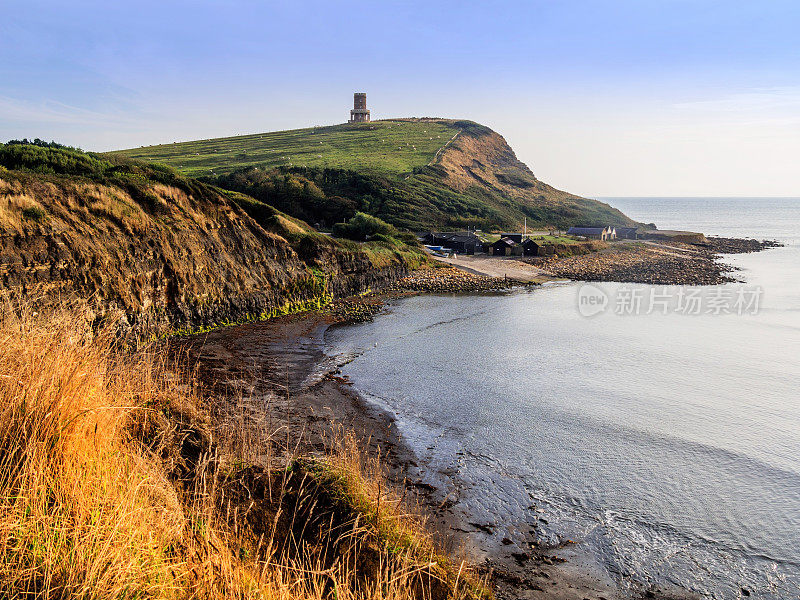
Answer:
[0, 0, 800, 197]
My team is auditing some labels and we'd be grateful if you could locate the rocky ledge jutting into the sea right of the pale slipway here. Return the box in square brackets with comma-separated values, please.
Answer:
[524, 237, 781, 285]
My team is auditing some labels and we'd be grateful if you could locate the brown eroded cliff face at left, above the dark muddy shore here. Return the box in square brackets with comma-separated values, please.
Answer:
[0, 159, 412, 334]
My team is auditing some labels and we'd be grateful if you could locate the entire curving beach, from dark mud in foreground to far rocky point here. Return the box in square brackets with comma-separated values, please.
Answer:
[167, 217, 788, 600]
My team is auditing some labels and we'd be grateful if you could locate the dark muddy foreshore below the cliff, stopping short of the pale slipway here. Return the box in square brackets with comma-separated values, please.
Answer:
[172, 269, 694, 600]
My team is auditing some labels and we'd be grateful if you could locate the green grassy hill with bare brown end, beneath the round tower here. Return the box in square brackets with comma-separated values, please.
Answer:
[109, 119, 634, 231]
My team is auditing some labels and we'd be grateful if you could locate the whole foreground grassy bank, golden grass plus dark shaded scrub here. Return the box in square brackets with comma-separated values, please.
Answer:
[0, 306, 484, 600]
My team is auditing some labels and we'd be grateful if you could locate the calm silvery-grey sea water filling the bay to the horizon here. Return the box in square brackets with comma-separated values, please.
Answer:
[326, 198, 800, 599]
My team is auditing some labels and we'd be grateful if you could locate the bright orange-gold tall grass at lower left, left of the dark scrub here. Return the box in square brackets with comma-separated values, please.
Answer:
[0, 309, 184, 598]
